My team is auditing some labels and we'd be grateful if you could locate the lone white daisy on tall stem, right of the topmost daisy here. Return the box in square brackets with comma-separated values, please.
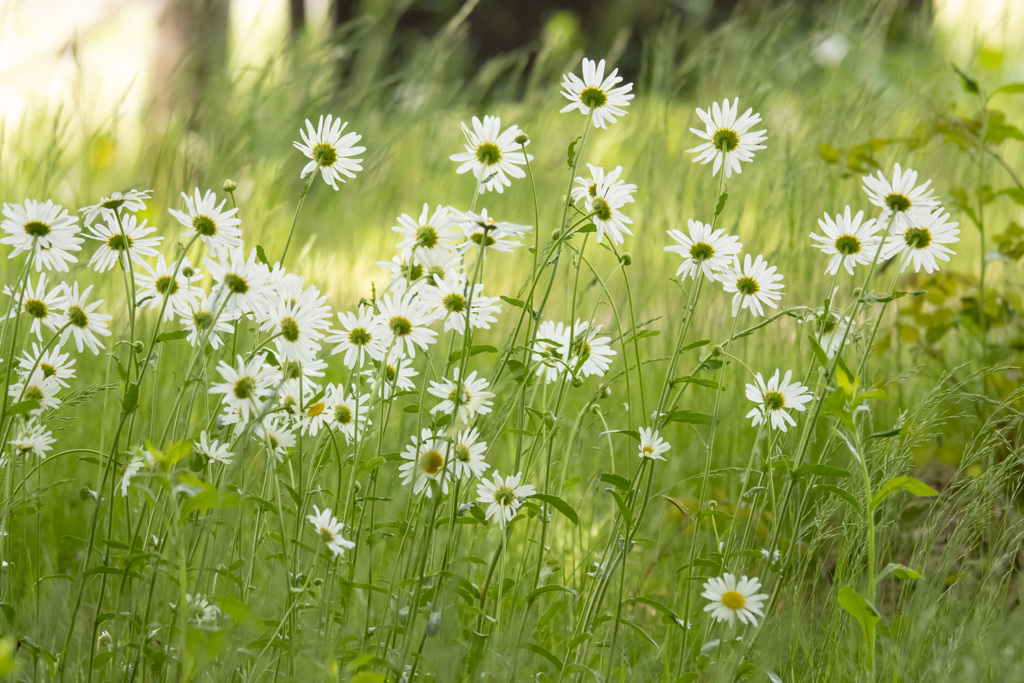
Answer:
[686, 97, 768, 178]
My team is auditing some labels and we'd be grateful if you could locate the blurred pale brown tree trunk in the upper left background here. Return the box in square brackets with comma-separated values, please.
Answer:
[154, 0, 230, 112]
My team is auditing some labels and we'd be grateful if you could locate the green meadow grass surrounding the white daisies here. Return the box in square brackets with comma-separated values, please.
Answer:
[0, 5, 1024, 681]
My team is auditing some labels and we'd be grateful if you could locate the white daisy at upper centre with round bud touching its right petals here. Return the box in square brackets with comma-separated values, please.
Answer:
[450, 116, 534, 195]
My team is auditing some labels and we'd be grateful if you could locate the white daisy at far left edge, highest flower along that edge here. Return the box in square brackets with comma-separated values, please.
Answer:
[0, 200, 84, 272]
